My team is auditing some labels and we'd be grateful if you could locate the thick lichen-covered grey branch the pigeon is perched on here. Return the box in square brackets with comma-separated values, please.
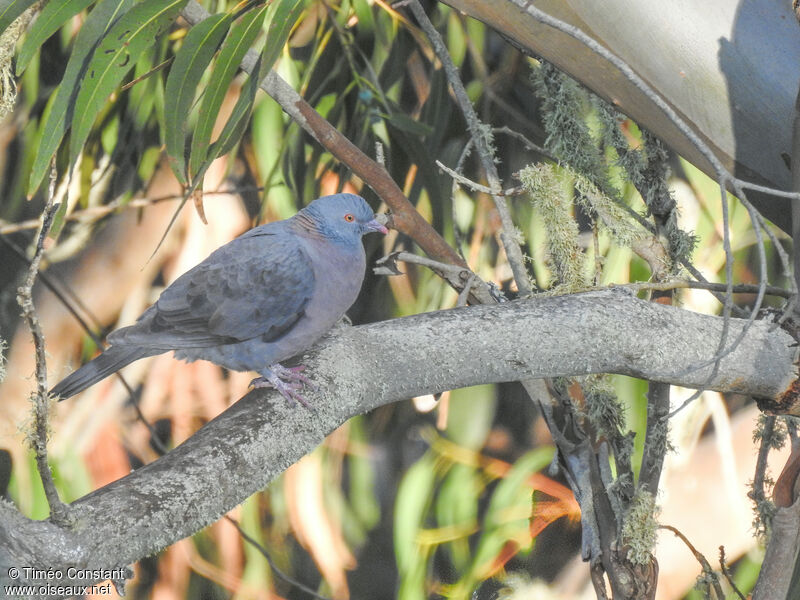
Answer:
[0, 291, 797, 592]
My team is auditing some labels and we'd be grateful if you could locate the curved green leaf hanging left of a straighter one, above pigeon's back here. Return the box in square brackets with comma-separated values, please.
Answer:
[164, 13, 232, 185]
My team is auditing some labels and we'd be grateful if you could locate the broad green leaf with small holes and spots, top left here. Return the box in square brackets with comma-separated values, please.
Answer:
[69, 0, 187, 164]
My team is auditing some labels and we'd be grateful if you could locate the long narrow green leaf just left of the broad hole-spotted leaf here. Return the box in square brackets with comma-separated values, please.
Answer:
[28, 0, 133, 195]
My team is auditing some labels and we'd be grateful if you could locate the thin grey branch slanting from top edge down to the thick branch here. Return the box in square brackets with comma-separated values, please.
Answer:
[408, 0, 533, 296]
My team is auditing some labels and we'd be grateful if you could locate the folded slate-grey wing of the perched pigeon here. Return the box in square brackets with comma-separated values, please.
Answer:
[108, 226, 314, 349]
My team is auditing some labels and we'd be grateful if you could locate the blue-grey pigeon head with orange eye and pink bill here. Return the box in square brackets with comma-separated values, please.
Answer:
[297, 194, 388, 244]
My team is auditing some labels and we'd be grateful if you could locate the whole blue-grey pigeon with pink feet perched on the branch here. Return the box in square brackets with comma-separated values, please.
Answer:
[50, 194, 387, 406]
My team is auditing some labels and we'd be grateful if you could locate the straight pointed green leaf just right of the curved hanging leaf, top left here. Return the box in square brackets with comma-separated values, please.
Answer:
[189, 7, 266, 185]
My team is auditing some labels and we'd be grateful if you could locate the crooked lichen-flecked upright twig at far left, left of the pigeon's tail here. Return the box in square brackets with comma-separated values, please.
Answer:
[17, 163, 69, 526]
